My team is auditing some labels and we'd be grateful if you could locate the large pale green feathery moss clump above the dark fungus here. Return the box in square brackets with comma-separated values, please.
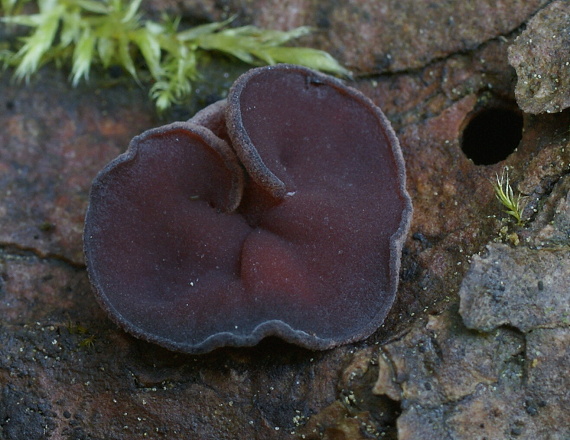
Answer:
[0, 0, 349, 111]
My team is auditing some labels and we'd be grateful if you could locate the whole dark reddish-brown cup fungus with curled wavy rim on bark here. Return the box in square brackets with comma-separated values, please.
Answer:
[84, 65, 412, 353]
